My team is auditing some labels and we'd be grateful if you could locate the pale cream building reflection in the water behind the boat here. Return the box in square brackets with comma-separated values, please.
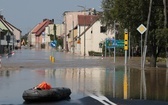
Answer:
[46, 68, 104, 93]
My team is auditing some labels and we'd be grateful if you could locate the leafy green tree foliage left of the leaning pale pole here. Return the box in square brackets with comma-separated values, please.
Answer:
[101, 0, 148, 49]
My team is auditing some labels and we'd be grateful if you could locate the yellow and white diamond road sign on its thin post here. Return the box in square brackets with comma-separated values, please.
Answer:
[137, 24, 147, 68]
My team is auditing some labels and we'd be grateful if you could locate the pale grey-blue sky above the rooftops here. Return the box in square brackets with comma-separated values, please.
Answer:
[0, 0, 102, 35]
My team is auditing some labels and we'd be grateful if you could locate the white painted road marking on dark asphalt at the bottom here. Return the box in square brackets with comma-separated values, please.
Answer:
[90, 95, 117, 105]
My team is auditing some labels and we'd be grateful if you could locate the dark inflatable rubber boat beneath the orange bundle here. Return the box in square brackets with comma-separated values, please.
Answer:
[22, 87, 71, 102]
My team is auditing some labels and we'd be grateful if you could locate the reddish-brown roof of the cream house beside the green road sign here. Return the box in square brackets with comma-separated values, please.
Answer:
[78, 15, 99, 26]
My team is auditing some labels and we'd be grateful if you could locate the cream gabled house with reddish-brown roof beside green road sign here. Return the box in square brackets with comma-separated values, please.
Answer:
[76, 15, 113, 56]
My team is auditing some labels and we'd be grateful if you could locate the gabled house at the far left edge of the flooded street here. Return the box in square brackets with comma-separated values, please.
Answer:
[0, 15, 21, 54]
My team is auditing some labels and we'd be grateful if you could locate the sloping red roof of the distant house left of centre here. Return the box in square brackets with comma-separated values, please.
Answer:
[32, 19, 54, 35]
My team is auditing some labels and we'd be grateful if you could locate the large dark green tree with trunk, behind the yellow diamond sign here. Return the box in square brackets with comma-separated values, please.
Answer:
[101, 0, 168, 67]
